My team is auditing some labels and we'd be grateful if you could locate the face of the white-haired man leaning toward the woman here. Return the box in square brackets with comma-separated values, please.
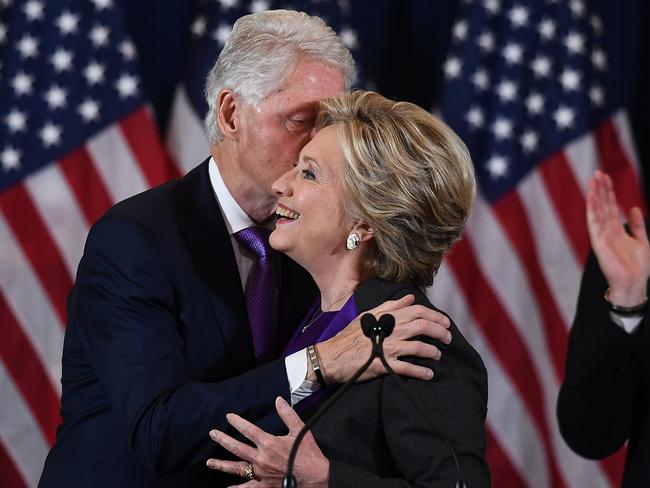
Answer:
[237, 57, 345, 215]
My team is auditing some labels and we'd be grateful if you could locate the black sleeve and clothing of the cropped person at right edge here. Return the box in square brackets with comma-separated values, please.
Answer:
[557, 221, 650, 488]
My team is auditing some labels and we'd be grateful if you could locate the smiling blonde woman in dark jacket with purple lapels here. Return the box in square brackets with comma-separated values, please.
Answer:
[208, 91, 490, 488]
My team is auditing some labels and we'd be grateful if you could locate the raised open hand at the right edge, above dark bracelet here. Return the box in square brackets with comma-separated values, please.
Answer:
[587, 171, 650, 307]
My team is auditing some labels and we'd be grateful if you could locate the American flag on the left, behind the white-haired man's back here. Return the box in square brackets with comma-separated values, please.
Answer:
[0, 0, 178, 487]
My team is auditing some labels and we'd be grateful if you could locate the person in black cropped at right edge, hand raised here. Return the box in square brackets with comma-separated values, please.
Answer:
[558, 171, 650, 488]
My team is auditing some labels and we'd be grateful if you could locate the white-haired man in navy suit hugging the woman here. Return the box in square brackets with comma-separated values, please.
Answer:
[39, 11, 449, 487]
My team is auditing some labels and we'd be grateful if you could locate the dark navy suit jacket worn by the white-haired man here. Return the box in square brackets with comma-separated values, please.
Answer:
[39, 161, 315, 488]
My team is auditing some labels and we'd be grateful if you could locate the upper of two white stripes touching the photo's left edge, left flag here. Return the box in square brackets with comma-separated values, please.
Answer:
[0, 212, 64, 394]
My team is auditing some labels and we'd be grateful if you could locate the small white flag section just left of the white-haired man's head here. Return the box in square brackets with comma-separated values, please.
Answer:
[166, 85, 210, 172]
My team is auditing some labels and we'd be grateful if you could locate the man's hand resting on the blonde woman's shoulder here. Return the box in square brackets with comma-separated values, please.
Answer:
[316, 295, 451, 384]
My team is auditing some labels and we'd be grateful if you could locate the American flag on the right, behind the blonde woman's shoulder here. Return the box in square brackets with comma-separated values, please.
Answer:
[431, 0, 643, 488]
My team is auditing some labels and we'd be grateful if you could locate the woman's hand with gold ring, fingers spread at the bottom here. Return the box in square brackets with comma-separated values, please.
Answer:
[207, 397, 329, 488]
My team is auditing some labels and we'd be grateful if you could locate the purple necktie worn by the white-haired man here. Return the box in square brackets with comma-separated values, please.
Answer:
[235, 227, 278, 364]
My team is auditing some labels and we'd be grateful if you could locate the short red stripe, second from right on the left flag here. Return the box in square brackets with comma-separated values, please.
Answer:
[59, 146, 111, 226]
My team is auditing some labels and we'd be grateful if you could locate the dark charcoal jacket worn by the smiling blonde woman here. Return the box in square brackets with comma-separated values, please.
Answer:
[306, 278, 490, 488]
